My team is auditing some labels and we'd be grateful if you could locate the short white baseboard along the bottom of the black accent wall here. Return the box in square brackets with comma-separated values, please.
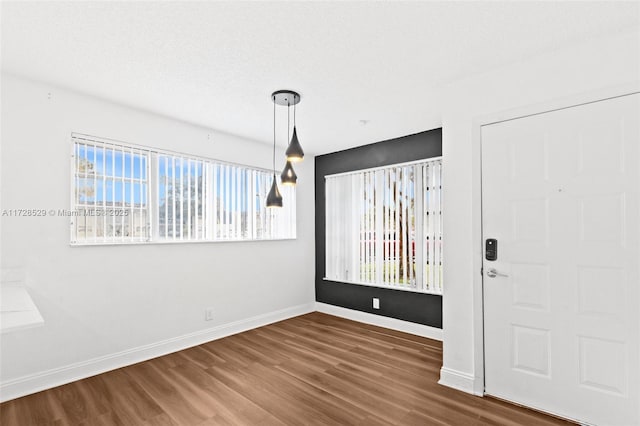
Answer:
[316, 302, 442, 341]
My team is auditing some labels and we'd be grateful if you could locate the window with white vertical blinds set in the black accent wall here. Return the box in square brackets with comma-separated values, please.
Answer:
[325, 158, 442, 294]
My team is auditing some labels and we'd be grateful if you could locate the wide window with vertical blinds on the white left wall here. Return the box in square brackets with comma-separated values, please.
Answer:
[70, 134, 296, 245]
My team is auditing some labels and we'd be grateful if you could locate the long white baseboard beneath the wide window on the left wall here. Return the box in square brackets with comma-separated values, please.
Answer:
[0, 303, 315, 402]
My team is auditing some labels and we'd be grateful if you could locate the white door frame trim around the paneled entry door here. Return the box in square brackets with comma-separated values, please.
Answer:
[472, 82, 640, 396]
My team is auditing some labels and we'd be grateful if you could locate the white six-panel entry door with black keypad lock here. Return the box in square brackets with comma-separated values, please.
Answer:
[482, 94, 640, 426]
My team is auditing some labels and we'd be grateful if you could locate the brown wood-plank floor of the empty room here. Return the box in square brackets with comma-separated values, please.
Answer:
[0, 312, 569, 426]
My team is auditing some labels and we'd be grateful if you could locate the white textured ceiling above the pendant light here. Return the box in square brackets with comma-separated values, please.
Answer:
[0, 1, 640, 154]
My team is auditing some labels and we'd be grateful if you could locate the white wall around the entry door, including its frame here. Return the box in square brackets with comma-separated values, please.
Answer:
[440, 30, 640, 394]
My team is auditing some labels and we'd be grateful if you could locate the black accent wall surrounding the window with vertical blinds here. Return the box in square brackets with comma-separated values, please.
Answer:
[315, 129, 442, 328]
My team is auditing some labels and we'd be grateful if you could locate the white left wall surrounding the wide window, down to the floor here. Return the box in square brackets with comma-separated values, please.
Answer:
[0, 75, 315, 399]
